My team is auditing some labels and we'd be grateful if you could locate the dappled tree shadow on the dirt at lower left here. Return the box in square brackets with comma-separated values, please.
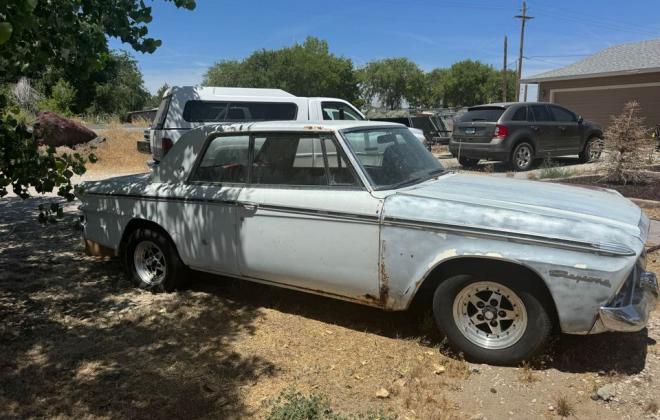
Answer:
[0, 198, 277, 418]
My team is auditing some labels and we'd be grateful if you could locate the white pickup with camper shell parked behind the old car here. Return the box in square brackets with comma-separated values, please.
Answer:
[137, 86, 366, 162]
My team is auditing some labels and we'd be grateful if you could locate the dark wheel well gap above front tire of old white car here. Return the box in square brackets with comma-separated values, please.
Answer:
[410, 257, 558, 326]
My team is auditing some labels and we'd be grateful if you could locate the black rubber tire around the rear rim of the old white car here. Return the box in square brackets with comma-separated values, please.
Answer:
[122, 228, 185, 292]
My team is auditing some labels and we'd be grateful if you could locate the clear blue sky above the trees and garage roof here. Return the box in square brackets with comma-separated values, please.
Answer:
[110, 0, 660, 99]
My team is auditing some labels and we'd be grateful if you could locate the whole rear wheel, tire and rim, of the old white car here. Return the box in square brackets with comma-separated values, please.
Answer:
[123, 228, 185, 292]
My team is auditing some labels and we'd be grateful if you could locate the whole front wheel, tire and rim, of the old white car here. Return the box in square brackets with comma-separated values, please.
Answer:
[433, 275, 552, 365]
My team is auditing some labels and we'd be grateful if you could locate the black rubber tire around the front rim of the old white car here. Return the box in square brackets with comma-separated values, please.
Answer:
[433, 275, 552, 365]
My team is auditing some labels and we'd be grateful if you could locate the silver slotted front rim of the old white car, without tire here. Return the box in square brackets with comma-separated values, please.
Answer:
[452, 281, 527, 350]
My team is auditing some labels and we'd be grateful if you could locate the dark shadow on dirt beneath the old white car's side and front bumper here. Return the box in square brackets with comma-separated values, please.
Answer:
[190, 272, 655, 375]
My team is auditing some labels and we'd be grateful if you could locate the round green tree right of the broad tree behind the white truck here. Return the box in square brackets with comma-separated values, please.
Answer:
[358, 58, 426, 109]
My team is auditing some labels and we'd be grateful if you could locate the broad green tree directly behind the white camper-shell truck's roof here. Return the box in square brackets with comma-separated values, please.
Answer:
[202, 37, 358, 101]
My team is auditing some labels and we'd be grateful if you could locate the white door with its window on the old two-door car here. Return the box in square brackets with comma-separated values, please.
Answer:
[238, 133, 381, 300]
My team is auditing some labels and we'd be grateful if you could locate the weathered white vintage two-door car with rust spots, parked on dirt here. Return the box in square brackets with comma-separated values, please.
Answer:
[78, 121, 658, 364]
